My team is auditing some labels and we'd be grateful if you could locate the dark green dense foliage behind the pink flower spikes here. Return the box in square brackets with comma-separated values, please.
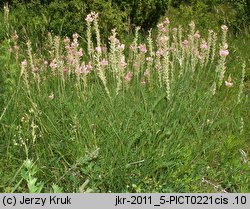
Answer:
[0, 0, 250, 38]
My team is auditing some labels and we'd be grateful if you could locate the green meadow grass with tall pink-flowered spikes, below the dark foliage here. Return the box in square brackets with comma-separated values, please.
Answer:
[0, 9, 250, 192]
